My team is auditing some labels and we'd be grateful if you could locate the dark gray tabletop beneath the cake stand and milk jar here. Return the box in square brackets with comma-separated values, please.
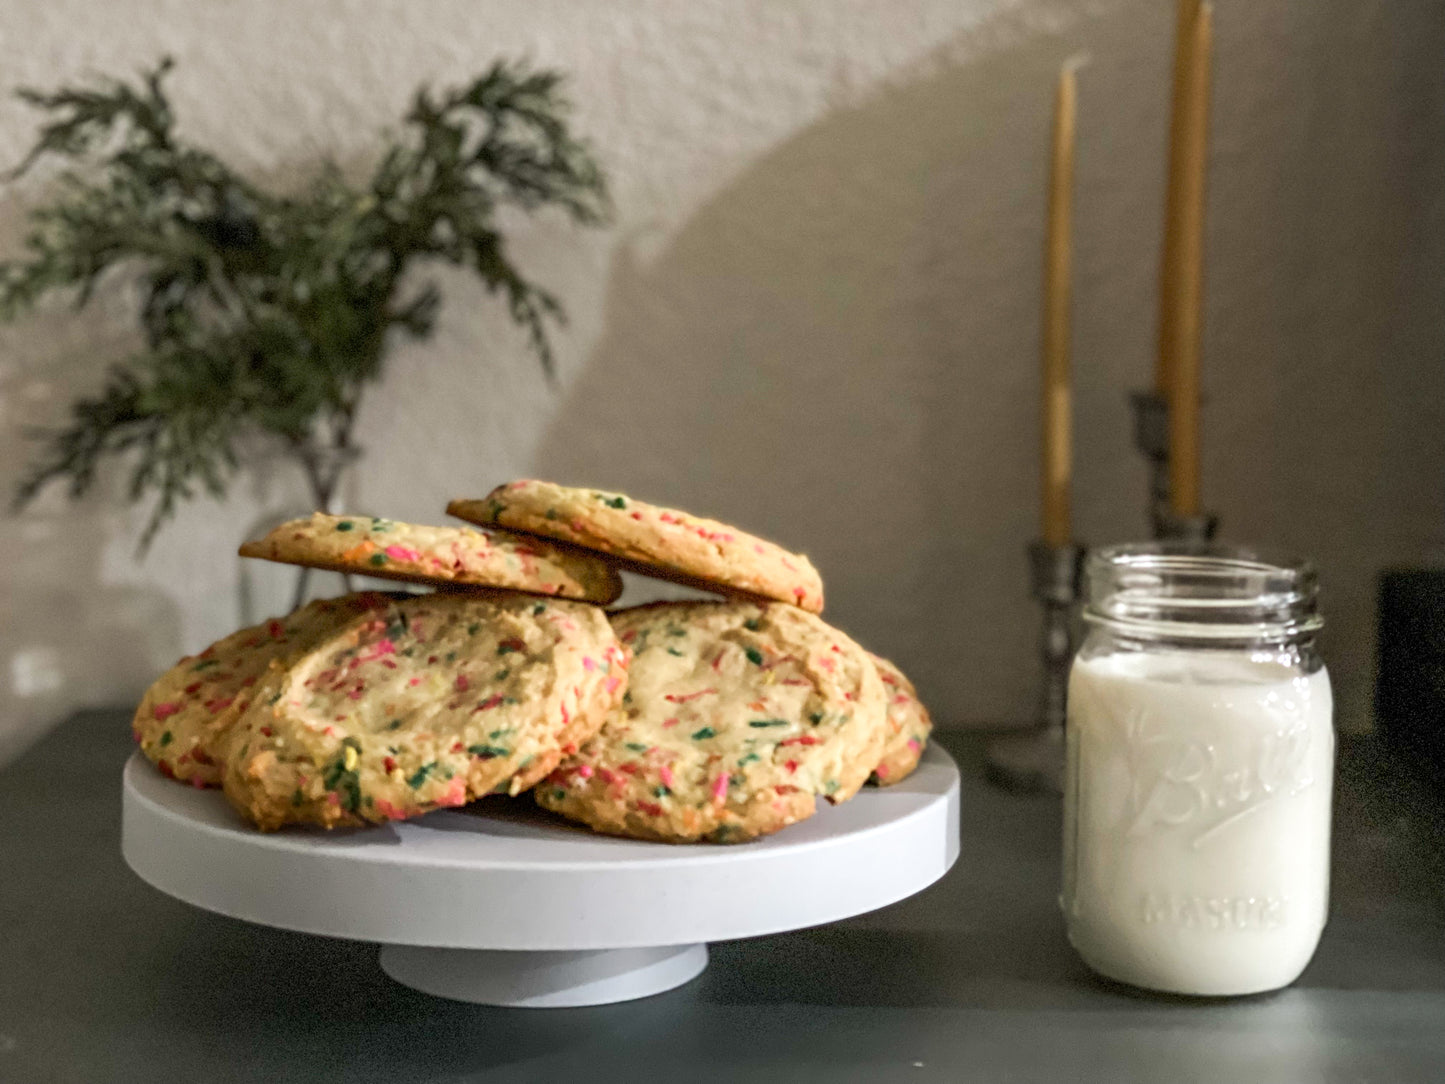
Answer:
[0, 713, 1445, 1084]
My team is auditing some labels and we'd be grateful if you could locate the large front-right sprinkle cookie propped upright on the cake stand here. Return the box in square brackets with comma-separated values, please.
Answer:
[532, 601, 887, 843]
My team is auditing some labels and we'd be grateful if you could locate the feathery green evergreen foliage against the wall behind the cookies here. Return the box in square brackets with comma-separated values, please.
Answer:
[0, 61, 607, 546]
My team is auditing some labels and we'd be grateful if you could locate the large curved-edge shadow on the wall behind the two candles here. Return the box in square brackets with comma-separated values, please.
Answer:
[535, 3, 1445, 728]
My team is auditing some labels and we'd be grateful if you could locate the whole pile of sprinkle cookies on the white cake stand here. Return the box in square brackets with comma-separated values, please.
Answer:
[134, 481, 931, 843]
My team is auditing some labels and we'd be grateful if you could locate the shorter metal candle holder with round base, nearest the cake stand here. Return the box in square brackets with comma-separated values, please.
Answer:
[987, 542, 1085, 793]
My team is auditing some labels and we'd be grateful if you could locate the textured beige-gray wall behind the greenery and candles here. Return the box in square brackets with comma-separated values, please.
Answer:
[0, 0, 1445, 752]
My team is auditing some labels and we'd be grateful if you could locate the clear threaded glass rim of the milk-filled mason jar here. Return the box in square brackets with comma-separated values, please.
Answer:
[1084, 542, 1324, 643]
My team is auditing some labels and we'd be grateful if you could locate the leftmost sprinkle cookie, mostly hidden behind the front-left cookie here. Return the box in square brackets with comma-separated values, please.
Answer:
[130, 591, 405, 786]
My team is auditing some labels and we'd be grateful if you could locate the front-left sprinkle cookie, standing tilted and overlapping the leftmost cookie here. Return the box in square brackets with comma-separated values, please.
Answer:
[223, 593, 627, 830]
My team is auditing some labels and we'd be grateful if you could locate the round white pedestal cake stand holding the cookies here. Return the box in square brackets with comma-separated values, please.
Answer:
[121, 747, 958, 1007]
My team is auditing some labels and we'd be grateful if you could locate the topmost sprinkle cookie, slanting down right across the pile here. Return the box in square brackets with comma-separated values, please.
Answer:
[447, 481, 822, 613]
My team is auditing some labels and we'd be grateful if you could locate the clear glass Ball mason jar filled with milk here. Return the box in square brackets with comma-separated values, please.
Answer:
[1061, 543, 1335, 994]
